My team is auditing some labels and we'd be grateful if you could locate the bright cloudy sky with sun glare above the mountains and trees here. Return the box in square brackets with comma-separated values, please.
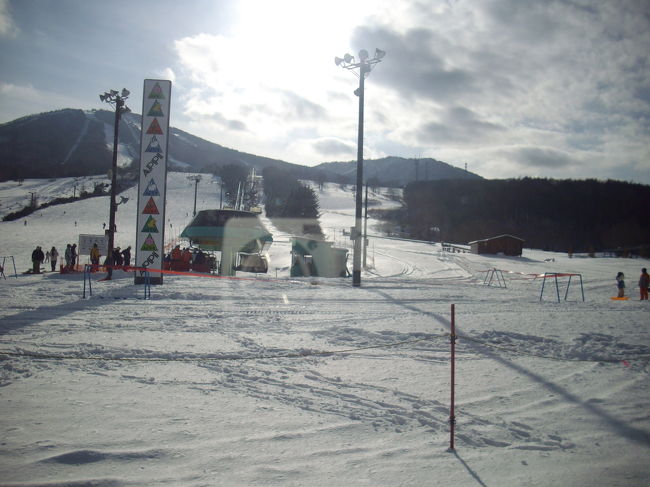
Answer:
[0, 0, 650, 184]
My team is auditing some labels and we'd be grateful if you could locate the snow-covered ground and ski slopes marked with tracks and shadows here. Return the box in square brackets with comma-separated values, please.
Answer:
[0, 177, 650, 486]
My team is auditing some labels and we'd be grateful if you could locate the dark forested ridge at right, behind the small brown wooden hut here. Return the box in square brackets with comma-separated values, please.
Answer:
[402, 178, 650, 252]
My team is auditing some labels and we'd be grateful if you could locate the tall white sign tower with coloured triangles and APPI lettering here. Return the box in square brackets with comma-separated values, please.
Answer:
[135, 79, 172, 284]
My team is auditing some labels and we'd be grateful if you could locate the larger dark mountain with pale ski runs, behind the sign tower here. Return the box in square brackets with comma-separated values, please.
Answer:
[0, 109, 326, 180]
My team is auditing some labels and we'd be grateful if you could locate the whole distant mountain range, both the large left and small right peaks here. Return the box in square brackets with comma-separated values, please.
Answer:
[0, 108, 480, 186]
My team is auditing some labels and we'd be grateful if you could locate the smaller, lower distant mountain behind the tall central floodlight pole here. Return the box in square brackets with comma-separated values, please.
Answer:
[316, 157, 482, 186]
